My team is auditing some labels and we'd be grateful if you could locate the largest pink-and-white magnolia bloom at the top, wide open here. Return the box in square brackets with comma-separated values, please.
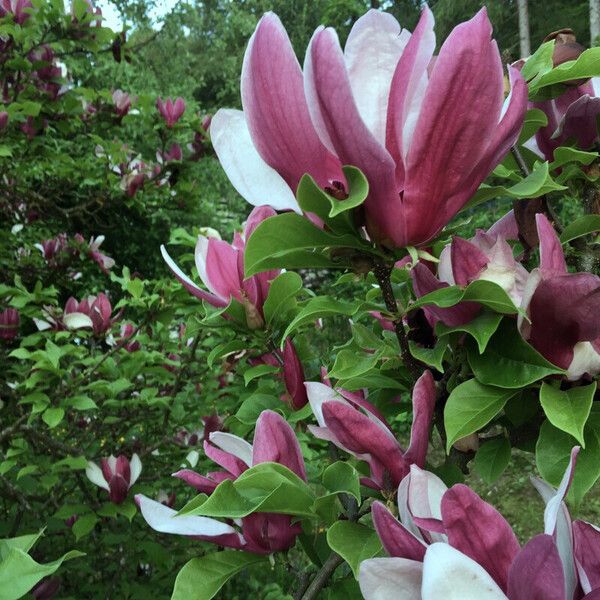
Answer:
[210, 8, 527, 247]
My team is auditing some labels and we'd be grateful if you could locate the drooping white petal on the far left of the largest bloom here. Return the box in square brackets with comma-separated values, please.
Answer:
[210, 108, 300, 212]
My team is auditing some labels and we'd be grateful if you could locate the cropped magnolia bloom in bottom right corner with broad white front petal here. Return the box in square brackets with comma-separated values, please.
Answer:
[359, 447, 588, 600]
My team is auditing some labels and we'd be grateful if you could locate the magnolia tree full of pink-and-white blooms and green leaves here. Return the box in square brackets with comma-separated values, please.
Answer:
[0, 3, 600, 600]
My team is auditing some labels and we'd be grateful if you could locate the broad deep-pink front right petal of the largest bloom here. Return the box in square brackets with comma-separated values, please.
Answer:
[404, 9, 510, 245]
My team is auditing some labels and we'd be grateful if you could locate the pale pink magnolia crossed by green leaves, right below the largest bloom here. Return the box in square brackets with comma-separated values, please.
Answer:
[411, 211, 529, 327]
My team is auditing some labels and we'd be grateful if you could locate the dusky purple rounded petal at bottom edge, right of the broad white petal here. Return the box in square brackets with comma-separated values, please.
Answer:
[508, 533, 566, 600]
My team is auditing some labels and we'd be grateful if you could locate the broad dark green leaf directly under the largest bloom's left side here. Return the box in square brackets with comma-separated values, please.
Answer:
[244, 213, 371, 277]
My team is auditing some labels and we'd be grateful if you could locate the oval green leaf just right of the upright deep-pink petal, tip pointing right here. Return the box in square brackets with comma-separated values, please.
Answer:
[444, 379, 517, 452]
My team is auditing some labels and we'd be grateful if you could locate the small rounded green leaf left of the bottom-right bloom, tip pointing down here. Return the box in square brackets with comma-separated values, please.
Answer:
[327, 521, 381, 579]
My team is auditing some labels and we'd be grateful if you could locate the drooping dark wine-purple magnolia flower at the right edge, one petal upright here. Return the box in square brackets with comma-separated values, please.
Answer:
[518, 214, 600, 381]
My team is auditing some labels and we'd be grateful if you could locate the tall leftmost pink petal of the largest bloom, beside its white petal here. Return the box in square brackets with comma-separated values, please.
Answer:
[241, 13, 344, 190]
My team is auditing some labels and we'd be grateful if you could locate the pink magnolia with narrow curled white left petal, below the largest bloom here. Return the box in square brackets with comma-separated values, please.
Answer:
[161, 206, 279, 329]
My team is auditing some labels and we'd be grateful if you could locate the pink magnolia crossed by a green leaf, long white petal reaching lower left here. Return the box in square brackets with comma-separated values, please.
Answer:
[136, 410, 306, 554]
